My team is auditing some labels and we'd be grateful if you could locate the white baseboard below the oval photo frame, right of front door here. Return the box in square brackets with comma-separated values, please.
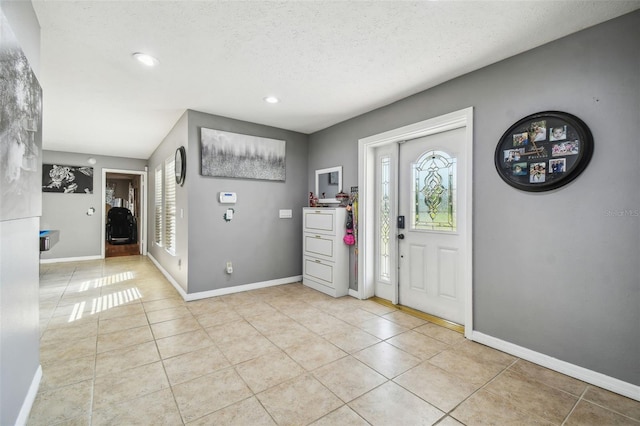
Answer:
[472, 331, 640, 401]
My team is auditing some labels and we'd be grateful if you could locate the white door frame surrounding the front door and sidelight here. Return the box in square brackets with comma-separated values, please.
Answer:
[358, 107, 473, 339]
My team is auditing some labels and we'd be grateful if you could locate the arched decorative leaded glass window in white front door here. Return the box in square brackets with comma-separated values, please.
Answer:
[411, 151, 456, 232]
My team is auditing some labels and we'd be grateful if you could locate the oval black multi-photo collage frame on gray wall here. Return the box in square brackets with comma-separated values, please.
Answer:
[495, 111, 593, 192]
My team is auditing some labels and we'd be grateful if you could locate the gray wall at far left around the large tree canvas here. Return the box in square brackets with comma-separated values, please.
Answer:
[0, 1, 40, 425]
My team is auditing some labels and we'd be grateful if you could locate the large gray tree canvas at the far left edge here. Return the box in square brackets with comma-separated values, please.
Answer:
[0, 11, 42, 220]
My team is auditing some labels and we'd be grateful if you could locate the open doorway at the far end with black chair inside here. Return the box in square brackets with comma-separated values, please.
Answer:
[102, 169, 147, 258]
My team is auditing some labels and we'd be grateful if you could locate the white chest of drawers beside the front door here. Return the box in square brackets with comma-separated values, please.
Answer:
[302, 207, 349, 297]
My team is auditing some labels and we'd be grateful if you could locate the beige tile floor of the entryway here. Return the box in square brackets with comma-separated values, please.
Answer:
[28, 256, 640, 426]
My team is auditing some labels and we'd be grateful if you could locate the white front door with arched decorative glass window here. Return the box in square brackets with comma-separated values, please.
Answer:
[397, 128, 471, 325]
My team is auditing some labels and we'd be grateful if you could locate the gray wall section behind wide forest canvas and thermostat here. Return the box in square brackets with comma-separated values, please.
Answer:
[185, 111, 308, 293]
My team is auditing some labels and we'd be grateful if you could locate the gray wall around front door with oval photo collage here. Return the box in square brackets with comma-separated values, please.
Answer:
[307, 12, 640, 385]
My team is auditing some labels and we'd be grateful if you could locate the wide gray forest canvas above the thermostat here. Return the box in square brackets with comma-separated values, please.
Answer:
[200, 128, 286, 181]
